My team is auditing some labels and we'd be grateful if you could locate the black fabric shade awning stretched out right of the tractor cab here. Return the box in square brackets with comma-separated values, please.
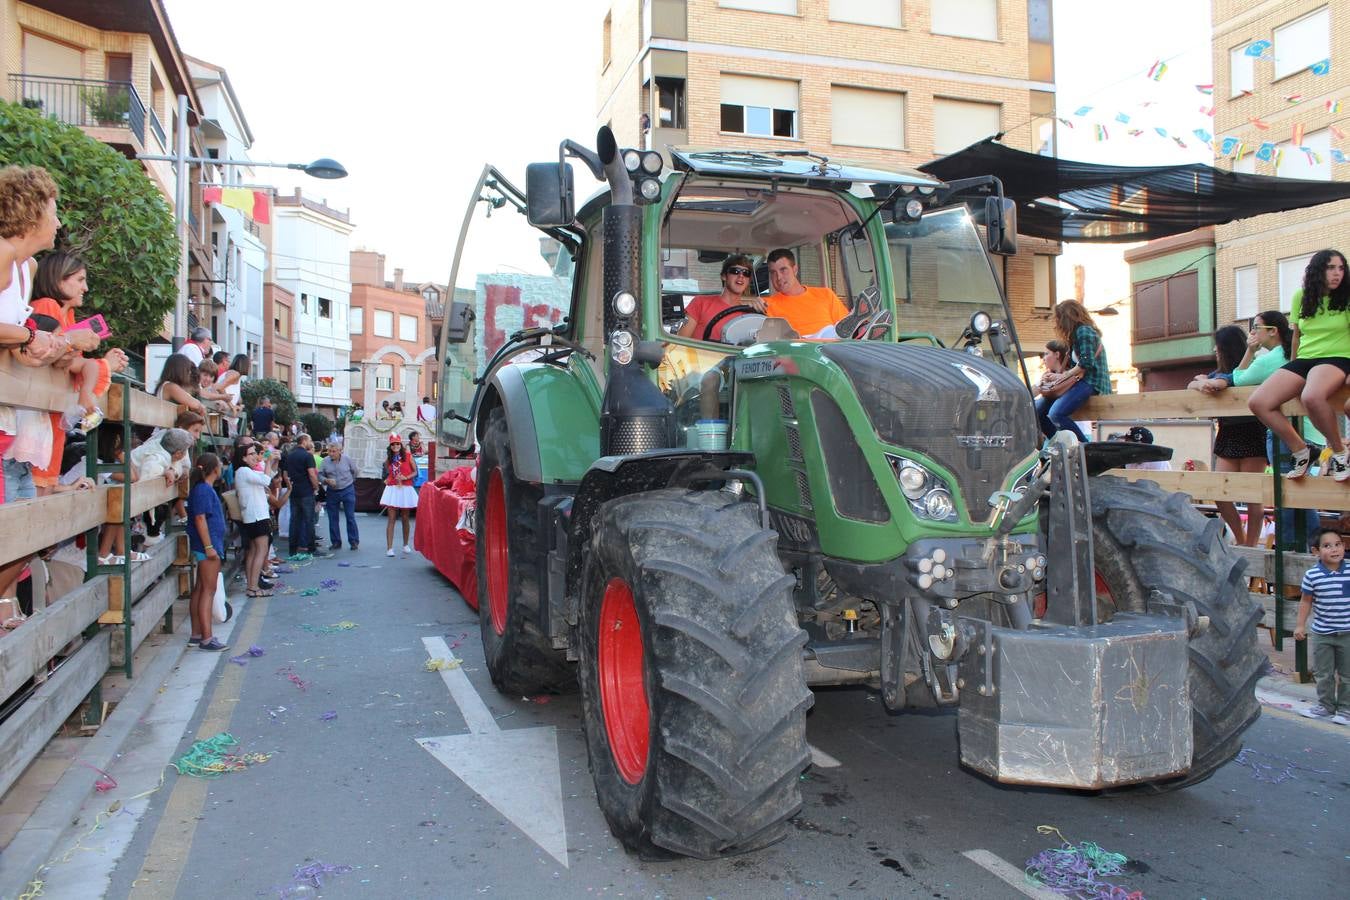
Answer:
[919, 138, 1350, 244]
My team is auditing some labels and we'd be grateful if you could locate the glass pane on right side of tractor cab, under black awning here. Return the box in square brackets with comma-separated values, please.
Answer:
[886, 206, 1007, 344]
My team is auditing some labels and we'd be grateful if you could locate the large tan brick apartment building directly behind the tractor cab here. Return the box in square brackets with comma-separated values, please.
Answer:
[597, 0, 1060, 345]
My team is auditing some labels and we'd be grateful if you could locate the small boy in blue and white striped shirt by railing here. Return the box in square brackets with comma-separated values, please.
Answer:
[1293, 528, 1350, 725]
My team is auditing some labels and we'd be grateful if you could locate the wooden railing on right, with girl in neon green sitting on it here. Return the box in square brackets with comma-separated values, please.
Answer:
[1075, 387, 1350, 679]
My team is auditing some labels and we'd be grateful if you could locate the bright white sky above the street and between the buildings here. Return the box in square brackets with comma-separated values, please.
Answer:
[163, 0, 1212, 288]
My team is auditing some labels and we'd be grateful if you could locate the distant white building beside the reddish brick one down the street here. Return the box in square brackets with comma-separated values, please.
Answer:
[270, 188, 356, 414]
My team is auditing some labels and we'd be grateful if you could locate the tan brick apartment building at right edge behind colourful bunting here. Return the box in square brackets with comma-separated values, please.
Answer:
[1214, 0, 1350, 324]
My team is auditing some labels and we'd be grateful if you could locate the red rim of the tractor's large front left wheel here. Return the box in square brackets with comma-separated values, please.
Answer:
[599, 578, 651, 784]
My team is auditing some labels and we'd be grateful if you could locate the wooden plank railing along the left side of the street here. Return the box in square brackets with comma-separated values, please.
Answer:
[0, 359, 188, 795]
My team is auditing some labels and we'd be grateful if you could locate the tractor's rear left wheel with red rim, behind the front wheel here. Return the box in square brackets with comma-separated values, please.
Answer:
[474, 406, 575, 695]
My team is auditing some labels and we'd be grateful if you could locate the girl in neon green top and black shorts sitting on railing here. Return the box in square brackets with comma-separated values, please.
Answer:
[1234, 250, 1350, 482]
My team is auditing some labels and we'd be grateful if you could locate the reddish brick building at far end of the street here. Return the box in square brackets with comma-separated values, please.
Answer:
[350, 250, 446, 414]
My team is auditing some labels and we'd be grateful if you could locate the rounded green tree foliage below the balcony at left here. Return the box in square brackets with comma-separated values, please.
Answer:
[0, 101, 178, 347]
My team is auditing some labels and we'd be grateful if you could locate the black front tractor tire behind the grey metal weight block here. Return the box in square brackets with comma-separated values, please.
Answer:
[1089, 475, 1266, 792]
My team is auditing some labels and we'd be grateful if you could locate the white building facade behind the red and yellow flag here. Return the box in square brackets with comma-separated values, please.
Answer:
[186, 57, 270, 374]
